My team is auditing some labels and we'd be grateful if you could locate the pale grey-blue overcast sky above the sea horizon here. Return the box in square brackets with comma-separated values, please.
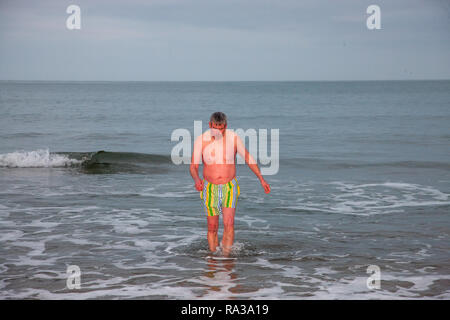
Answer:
[0, 0, 450, 81]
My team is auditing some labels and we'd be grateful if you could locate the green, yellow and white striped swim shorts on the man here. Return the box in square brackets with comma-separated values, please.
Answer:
[200, 178, 241, 217]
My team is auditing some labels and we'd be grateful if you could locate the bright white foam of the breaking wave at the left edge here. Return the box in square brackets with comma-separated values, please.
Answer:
[0, 149, 83, 168]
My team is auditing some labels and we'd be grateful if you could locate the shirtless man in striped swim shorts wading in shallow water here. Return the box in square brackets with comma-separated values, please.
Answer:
[190, 112, 270, 256]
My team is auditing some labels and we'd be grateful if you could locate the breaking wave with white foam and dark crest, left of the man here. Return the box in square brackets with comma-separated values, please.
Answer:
[0, 149, 171, 173]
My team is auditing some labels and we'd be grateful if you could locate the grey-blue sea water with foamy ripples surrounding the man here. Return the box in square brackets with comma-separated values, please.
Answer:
[0, 81, 450, 299]
